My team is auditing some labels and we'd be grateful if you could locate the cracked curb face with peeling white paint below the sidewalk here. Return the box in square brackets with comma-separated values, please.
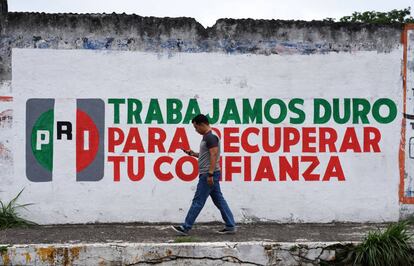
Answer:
[0, 242, 372, 266]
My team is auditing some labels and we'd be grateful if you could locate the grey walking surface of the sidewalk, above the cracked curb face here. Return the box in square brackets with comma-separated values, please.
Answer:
[0, 223, 408, 244]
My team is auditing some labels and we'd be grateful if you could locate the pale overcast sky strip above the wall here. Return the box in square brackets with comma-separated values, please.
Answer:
[8, 0, 414, 27]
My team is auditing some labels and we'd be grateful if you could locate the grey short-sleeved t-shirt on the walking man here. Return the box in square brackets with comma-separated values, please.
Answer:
[198, 130, 220, 174]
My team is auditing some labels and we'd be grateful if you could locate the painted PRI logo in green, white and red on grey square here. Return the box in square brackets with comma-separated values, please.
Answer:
[26, 99, 105, 182]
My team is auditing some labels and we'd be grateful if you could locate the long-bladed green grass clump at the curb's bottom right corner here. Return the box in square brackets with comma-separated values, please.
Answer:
[354, 221, 414, 266]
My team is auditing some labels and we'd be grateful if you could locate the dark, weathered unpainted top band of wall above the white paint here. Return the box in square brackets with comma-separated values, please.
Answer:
[0, 12, 401, 84]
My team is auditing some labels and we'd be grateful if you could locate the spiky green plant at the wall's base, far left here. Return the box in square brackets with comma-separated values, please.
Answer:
[0, 189, 36, 230]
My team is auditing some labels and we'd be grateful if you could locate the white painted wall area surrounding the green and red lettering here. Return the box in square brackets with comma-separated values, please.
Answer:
[5, 49, 402, 224]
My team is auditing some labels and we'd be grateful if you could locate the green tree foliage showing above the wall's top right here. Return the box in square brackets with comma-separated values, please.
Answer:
[324, 7, 414, 24]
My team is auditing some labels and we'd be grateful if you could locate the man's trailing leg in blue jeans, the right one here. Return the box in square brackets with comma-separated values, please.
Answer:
[210, 172, 236, 230]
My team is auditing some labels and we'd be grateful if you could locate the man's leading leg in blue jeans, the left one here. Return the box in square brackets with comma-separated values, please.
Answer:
[183, 175, 211, 231]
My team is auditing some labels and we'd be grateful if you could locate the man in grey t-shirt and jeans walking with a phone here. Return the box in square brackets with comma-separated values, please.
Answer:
[172, 114, 236, 235]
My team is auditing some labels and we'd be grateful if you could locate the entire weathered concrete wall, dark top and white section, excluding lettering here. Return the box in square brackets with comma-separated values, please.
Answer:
[0, 0, 414, 224]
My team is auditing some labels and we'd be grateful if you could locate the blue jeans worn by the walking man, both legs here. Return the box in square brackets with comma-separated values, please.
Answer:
[183, 171, 236, 231]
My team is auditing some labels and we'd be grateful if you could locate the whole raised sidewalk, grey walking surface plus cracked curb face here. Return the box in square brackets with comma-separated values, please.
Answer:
[0, 223, 414, 265]
